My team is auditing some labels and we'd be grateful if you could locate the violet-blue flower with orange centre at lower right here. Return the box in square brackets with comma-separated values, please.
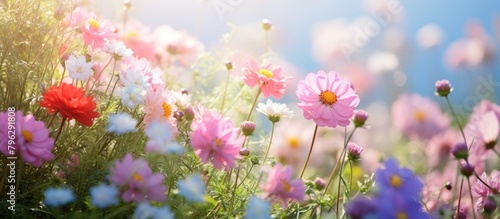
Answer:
[375, 158, 423, 198]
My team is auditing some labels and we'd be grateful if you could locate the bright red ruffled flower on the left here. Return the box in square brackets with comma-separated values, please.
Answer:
[40, 83, 100, 127]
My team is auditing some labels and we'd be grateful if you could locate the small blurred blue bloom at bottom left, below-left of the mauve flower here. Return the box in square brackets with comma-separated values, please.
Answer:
[90, 184, 118, 208]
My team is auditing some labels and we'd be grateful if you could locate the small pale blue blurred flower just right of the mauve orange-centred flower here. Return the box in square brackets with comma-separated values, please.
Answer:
[177, 174, 206, 202]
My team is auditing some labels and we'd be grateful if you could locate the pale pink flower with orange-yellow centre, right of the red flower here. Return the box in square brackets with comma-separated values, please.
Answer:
[142, 88, 177, 124]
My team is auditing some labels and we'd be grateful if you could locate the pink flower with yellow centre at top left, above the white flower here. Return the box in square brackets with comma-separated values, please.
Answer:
[83, 18, 117, 49]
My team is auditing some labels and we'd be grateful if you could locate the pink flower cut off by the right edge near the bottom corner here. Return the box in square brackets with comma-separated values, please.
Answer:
[472, 170, 500, 211]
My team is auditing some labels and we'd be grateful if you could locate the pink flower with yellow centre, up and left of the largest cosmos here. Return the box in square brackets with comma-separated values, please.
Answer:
[242, 58, 292, 99]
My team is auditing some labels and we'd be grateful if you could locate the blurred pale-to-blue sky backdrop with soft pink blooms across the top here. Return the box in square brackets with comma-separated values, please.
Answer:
[93, 0, 500, 114]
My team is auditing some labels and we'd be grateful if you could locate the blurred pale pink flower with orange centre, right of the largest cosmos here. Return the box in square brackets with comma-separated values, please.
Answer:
[391, 94, 450, 140]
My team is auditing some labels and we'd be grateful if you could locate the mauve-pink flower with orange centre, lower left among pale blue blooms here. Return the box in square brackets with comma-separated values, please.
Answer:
[110, 154, 166, 202]
